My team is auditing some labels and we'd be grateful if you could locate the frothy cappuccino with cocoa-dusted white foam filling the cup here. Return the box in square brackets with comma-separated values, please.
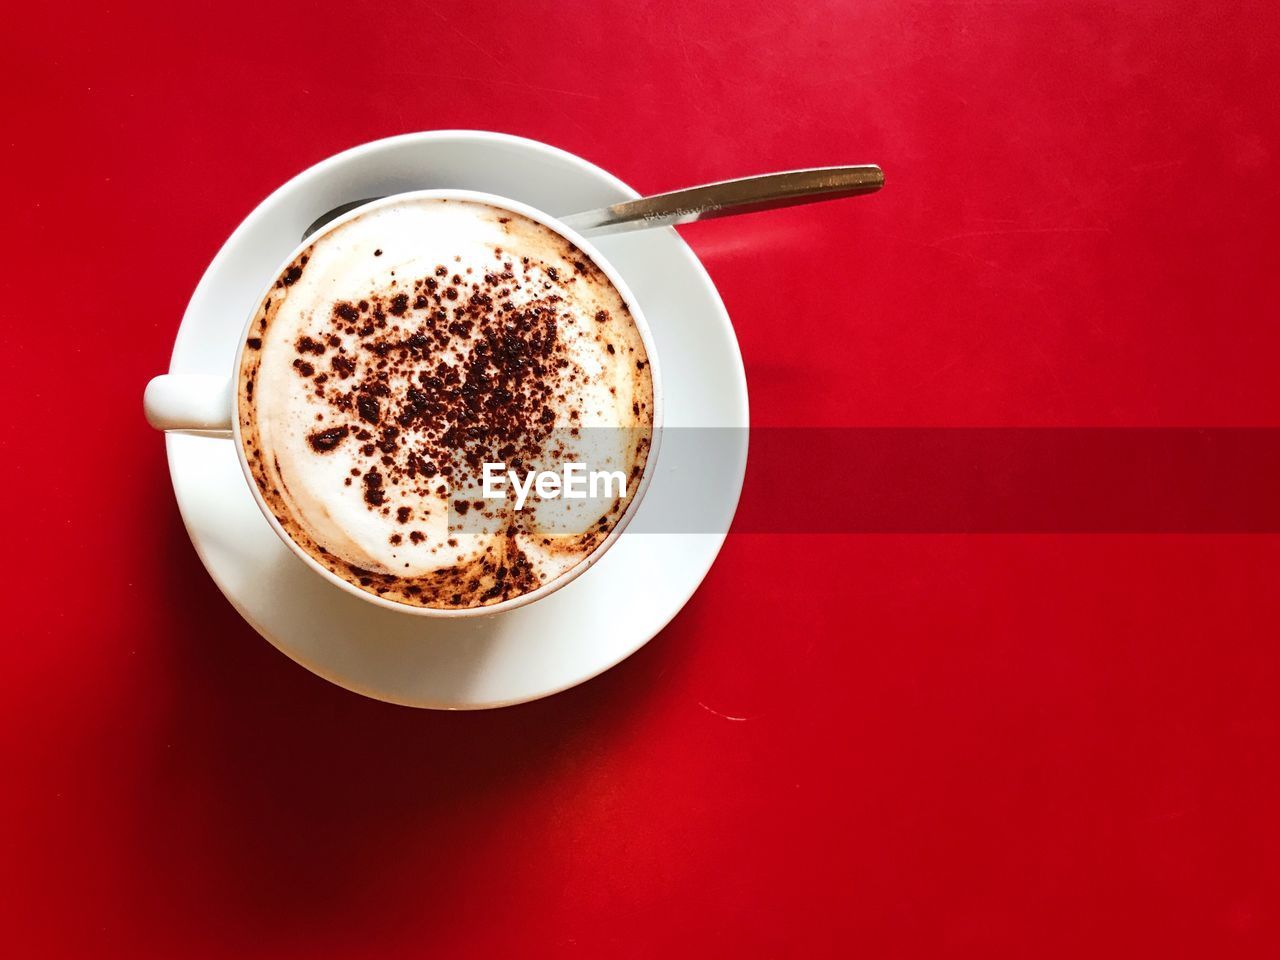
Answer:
[237, 197, 654, 609]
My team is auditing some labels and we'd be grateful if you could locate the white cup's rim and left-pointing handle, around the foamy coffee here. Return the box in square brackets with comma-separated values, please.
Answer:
[143, 189, 663, 617]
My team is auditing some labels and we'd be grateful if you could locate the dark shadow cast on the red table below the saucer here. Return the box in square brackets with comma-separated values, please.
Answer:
[138, 511, 701, 940]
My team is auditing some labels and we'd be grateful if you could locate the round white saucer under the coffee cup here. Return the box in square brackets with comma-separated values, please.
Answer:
[168, 131, 748, 709]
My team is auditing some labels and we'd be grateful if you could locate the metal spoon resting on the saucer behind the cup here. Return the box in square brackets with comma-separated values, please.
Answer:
[302, 164, 884, 239]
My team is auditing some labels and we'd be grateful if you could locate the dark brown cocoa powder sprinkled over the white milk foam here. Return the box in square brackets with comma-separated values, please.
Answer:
[246, 218, 644, 607]
